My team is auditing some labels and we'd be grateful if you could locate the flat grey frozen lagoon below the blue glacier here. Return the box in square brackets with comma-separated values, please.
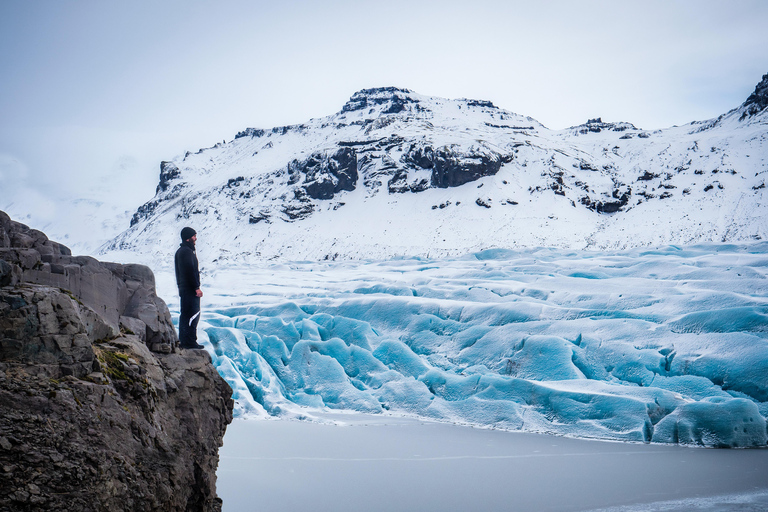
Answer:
[218, 414, 768, 512]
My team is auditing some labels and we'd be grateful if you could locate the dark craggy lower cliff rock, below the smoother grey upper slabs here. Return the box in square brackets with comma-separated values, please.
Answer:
[0, 304, 232, 512]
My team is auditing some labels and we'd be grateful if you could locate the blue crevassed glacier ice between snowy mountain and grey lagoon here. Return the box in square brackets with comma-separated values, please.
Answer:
[177, 242, 768, 447]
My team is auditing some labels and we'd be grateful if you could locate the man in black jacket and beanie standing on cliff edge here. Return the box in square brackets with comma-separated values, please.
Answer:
[174, 228, 203, 348]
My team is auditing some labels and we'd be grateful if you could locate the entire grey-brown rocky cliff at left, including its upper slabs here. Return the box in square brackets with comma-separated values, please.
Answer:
[0, 212, 233, 511]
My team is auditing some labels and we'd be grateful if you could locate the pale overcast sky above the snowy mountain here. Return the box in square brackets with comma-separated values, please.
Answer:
[0, 0, 768, 239]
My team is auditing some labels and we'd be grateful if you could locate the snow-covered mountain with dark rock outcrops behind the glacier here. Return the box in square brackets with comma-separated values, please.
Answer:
[102, 75, 768, 262]
